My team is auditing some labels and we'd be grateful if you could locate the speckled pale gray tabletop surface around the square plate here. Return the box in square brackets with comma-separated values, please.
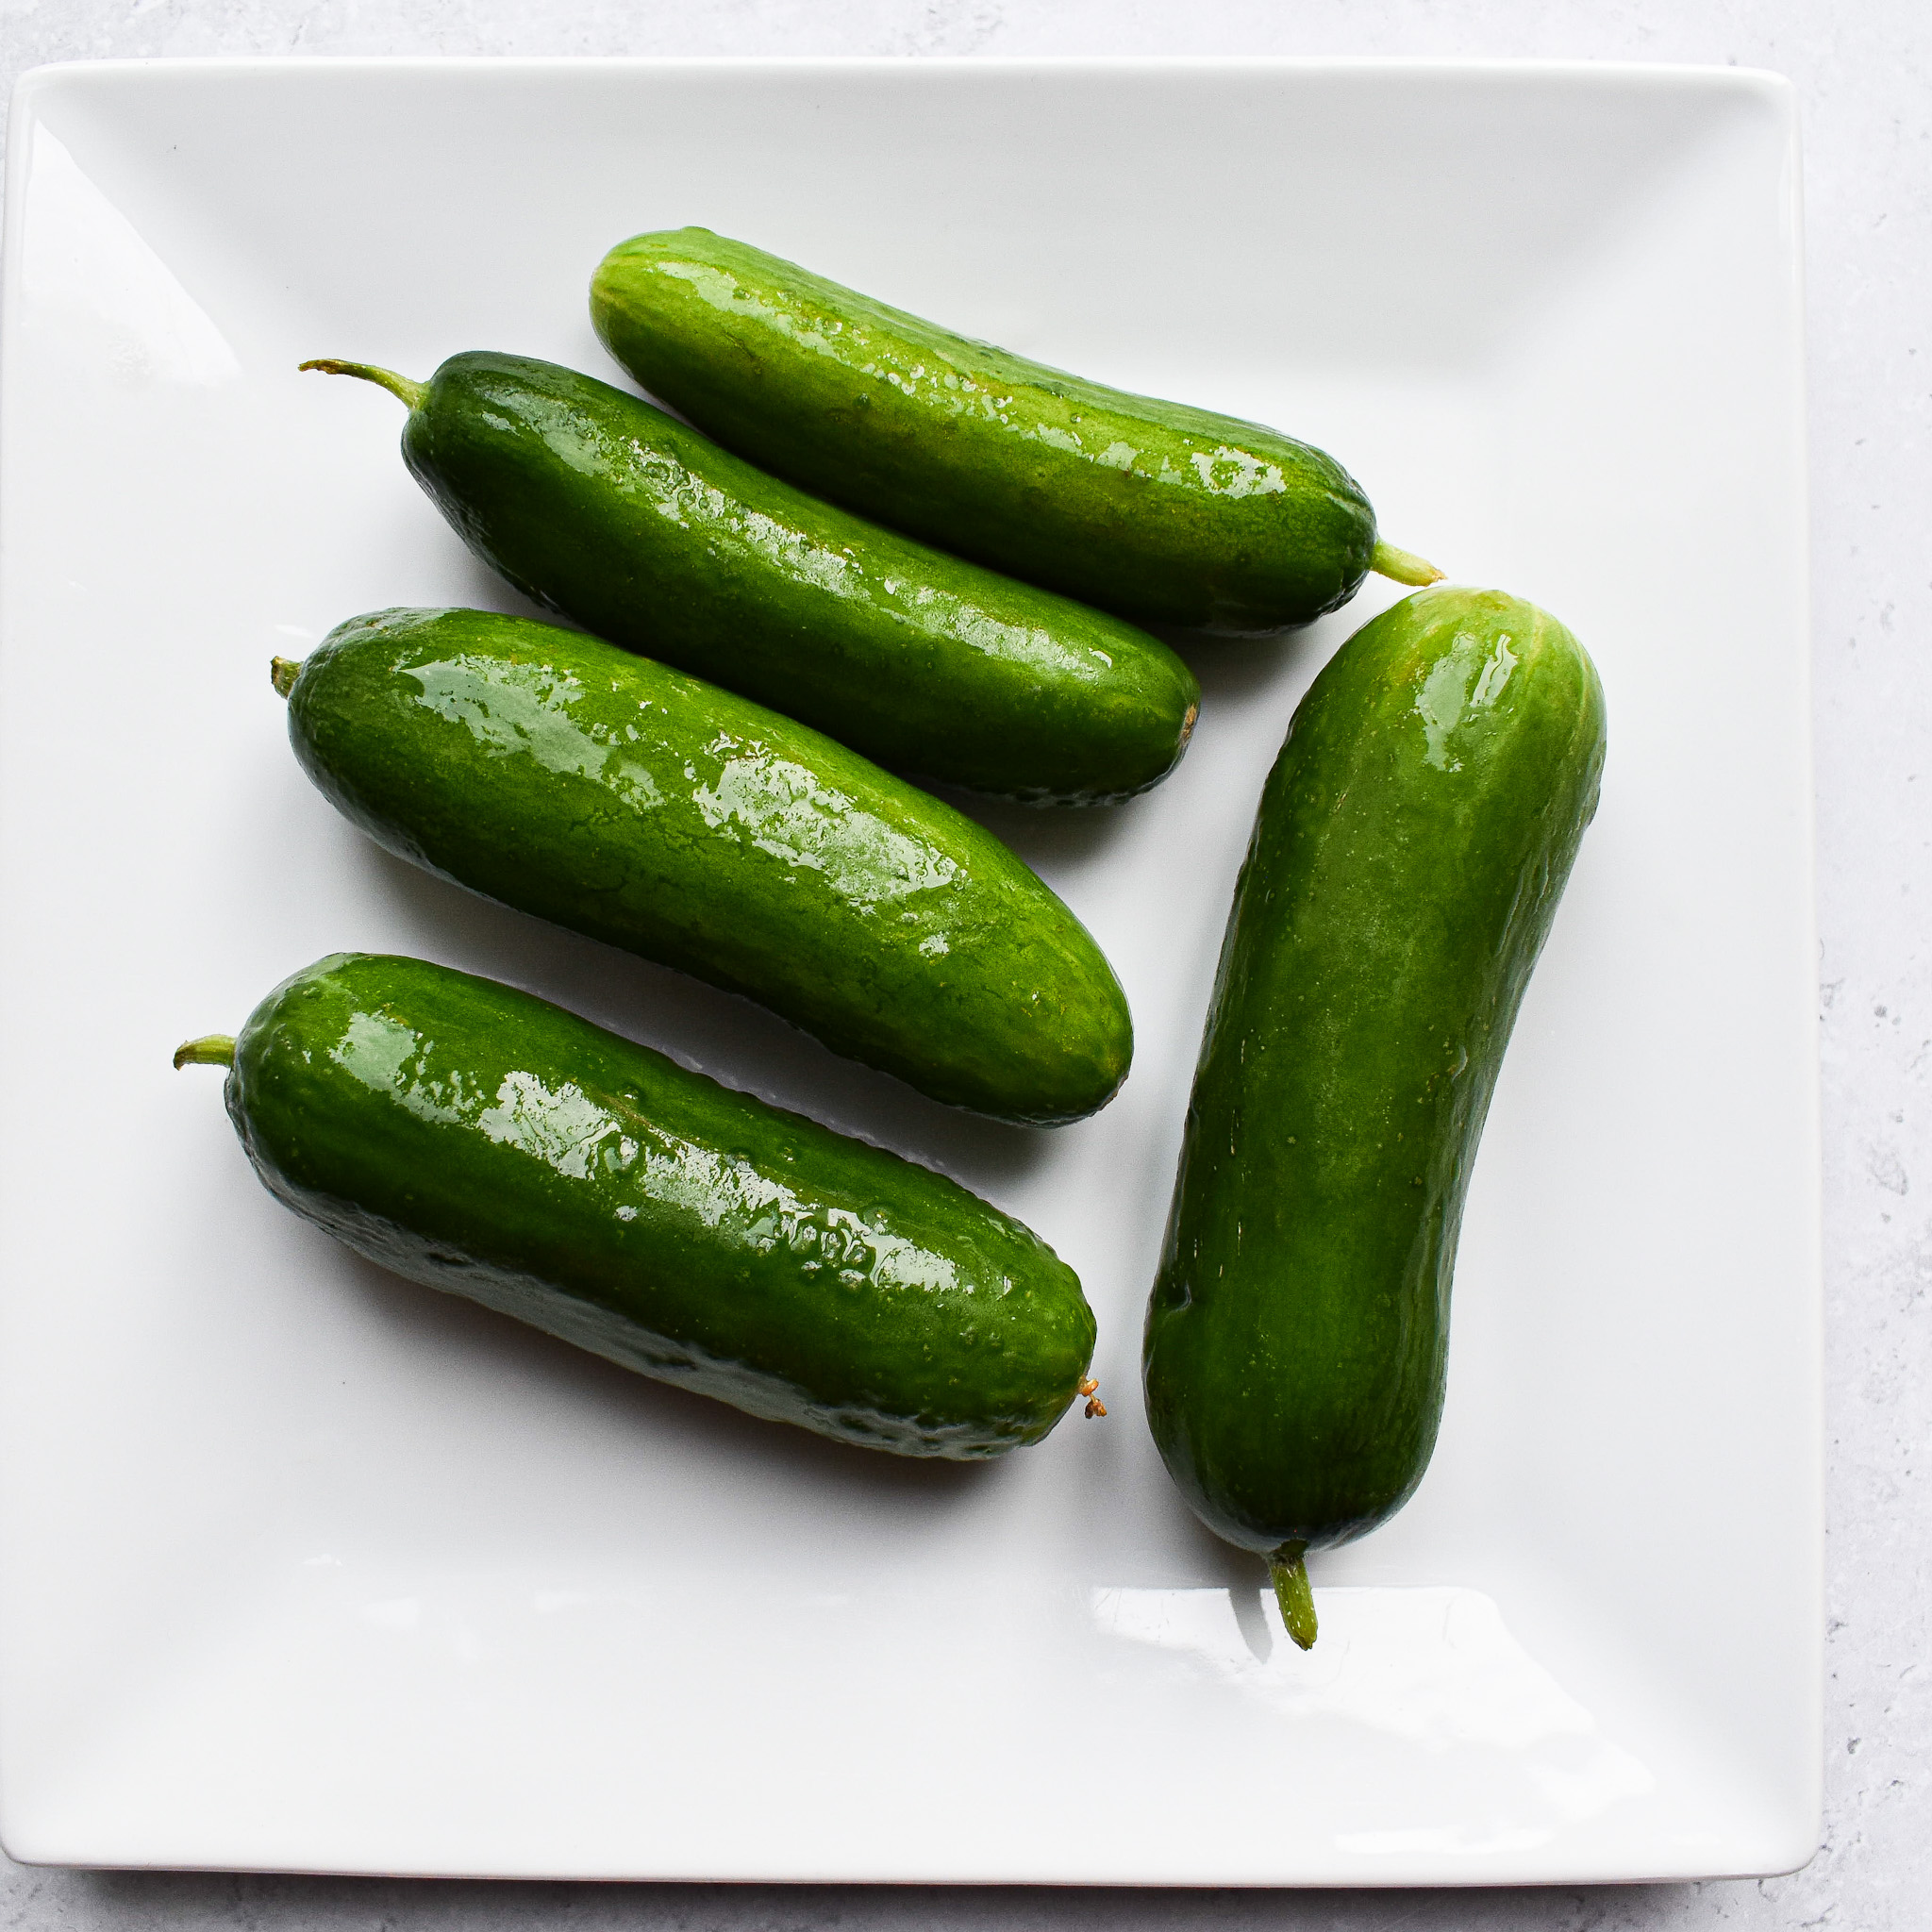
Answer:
[0, 0, 1932, 1932]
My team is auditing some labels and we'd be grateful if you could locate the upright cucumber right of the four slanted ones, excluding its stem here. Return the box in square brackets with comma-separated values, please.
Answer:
[1143, 590, 1604, 1552]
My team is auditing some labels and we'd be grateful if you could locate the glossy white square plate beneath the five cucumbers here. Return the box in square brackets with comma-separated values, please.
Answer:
[0, 62, 1820, 1884]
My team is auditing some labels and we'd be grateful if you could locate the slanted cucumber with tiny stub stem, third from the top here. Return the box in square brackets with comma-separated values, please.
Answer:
[276, 610, 1132, 1124]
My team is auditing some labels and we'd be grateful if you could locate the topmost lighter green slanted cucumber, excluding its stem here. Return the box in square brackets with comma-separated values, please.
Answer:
[591, 228, 1375, 634]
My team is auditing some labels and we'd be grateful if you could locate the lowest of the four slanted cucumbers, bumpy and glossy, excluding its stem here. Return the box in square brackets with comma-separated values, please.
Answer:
[226, 953, 1093, 1460]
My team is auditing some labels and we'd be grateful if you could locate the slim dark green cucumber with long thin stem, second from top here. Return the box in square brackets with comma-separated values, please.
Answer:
[304, 354, 1200, 804]
